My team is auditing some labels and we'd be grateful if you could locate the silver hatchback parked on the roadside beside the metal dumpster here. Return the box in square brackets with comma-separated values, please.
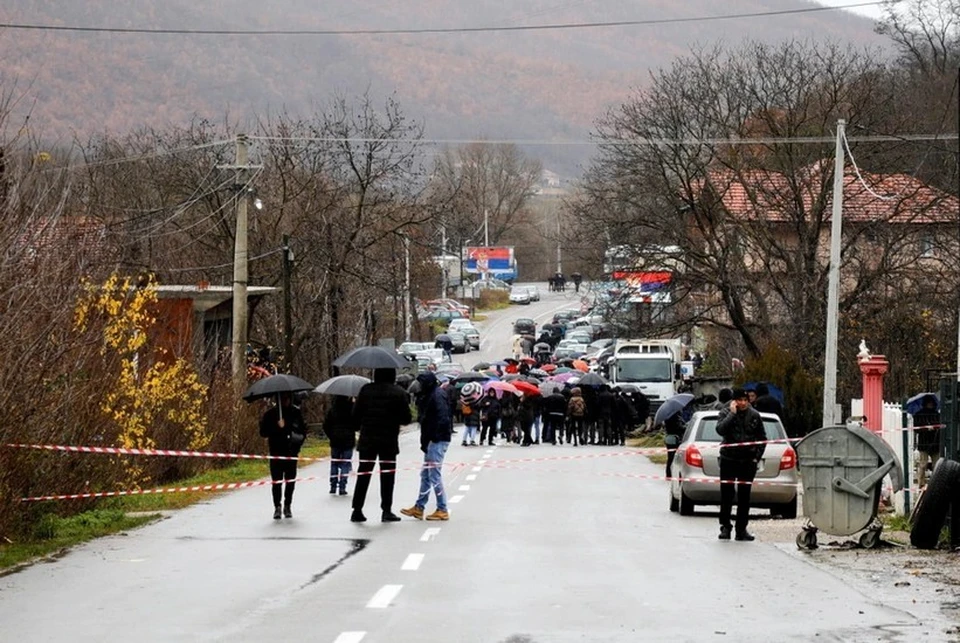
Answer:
[670, 411, 799, 518]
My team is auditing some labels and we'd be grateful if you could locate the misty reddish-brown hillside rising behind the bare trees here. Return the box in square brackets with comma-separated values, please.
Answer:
[0, 0, 883, 172]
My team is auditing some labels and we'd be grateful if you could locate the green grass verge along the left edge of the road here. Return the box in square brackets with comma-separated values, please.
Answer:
[0, 437, 330, 570]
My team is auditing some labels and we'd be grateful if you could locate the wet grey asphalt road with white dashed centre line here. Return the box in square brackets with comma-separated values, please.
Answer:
[0, 287, 949, 643]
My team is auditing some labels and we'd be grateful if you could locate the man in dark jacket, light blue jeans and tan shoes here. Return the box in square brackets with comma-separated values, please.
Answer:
[400, 371, 453, 520]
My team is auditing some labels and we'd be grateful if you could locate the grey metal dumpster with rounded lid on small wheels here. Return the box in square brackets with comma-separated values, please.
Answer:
[796, 425, 903, 549]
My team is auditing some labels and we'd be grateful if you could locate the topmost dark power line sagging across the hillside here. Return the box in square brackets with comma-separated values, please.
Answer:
[0, 0, 885, 36]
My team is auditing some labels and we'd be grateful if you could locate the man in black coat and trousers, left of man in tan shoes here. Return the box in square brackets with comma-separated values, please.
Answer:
[350, 368, 411, 522]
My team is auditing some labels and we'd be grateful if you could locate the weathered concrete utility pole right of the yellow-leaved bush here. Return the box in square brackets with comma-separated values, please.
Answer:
[231, 134, 249, 391]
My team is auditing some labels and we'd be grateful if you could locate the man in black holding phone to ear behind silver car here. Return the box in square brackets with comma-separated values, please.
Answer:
[717, 388, 766, 541]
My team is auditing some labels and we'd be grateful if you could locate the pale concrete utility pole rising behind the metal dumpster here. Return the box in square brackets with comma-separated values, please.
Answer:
[821, 118, 846, 426]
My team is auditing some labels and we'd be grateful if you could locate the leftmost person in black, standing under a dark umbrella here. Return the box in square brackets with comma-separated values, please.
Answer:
[260, 393, 307, 520]
